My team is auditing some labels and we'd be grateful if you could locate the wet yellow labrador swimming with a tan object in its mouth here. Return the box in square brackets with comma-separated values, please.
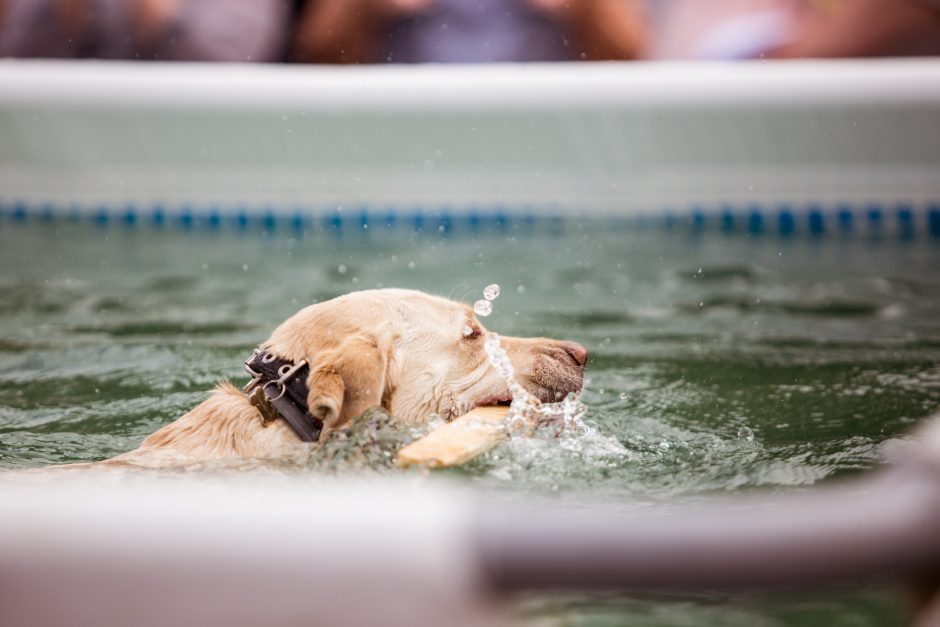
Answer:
[86, 289, 587, 467]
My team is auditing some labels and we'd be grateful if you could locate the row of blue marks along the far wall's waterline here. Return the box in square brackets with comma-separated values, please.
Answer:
[0, 201, 940, 240]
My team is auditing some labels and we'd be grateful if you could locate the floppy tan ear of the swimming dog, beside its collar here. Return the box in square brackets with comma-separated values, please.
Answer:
[307, 337, 390, 428]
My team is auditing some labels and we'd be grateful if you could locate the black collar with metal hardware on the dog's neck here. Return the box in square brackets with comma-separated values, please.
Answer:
[245, 348, 323, 442]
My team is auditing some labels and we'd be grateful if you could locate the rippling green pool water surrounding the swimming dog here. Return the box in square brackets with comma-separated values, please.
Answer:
[0, 223, 940, 625]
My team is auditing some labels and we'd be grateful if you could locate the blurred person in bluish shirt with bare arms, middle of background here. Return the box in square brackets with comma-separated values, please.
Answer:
[292, 0, 648, 63]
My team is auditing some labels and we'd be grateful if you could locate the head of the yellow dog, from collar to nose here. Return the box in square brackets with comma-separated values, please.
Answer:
[263, 289, 587, 428]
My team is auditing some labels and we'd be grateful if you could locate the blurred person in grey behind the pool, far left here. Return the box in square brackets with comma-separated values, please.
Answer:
[0, 0, 292, 61]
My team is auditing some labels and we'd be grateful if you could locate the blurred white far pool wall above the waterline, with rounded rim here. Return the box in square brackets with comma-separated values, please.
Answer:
[0, 59, 940, 229]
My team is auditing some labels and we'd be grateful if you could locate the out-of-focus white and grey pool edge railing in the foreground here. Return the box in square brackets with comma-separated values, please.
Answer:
[0, 419, 940, 627]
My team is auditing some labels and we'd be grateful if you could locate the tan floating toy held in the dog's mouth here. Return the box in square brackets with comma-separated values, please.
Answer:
[398, 405, 509, 467]
